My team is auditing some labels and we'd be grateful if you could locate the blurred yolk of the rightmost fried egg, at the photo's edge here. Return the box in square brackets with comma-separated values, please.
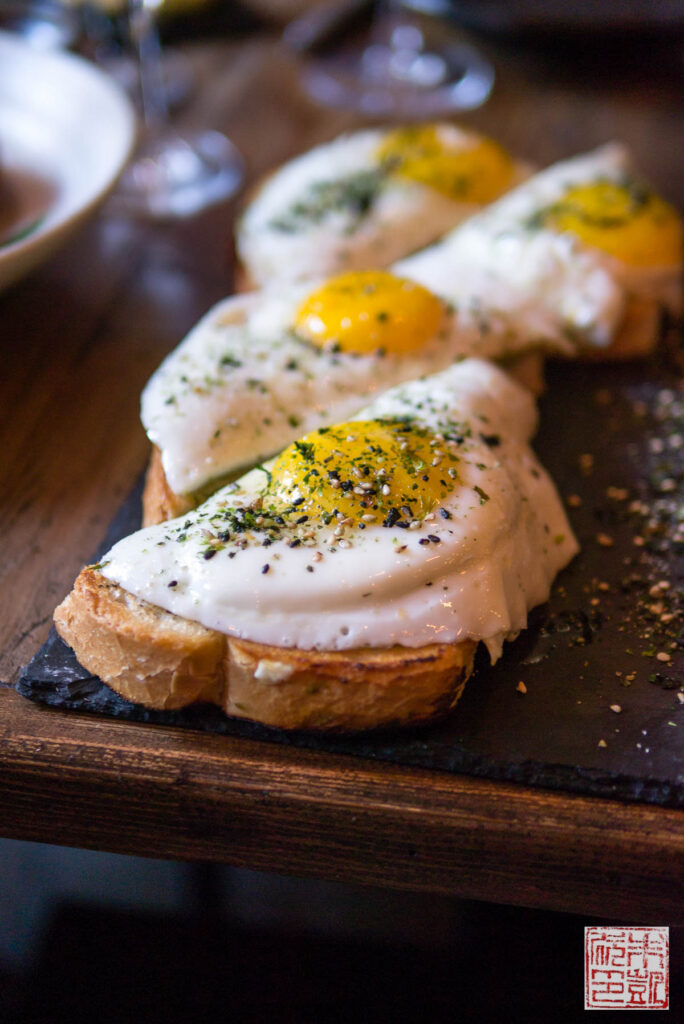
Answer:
[545, 181, 683, 266]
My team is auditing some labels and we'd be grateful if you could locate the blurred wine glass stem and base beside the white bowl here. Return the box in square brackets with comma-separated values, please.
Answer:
[112, 0, 244, 219]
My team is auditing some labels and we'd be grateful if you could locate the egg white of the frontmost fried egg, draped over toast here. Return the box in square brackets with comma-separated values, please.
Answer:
[109, 359, 578, 658]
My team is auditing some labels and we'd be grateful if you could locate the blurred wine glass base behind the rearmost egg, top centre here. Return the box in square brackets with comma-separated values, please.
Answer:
[286, 0, 495, 119]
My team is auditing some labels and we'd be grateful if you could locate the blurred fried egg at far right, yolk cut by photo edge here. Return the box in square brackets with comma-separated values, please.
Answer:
[393, 143, 682, 352]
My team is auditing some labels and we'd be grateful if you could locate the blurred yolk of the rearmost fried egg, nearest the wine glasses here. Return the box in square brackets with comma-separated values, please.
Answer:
[378, 125, 514, 205]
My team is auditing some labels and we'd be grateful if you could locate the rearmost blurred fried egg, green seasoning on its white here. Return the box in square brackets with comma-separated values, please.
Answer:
[237, 124, 529, 286]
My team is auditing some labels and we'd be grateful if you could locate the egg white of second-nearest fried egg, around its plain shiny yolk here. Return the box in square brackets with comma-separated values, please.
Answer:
[141, 284, 460, 494]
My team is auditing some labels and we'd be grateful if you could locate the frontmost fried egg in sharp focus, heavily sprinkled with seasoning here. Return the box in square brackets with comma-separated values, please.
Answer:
[109, 359, 578, 658]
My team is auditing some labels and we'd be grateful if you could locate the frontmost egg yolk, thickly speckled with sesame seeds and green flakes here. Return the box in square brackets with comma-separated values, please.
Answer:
[268, 420, 459, 526]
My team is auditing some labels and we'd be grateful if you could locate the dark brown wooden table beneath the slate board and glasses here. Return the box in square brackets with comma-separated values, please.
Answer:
[0, 24, 684, 924]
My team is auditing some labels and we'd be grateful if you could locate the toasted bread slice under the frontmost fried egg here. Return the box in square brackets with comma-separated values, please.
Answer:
[54, 566, 477, 731]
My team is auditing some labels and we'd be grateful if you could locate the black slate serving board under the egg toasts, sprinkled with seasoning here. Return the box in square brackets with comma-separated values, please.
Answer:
[17, 353, 684, 806]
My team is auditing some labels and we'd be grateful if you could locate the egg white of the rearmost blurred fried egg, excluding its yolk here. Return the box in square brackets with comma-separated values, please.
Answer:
[237, 124, 529, 286]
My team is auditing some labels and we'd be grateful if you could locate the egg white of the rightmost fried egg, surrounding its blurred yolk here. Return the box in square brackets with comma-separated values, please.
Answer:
[392, 142, 682, 346]
